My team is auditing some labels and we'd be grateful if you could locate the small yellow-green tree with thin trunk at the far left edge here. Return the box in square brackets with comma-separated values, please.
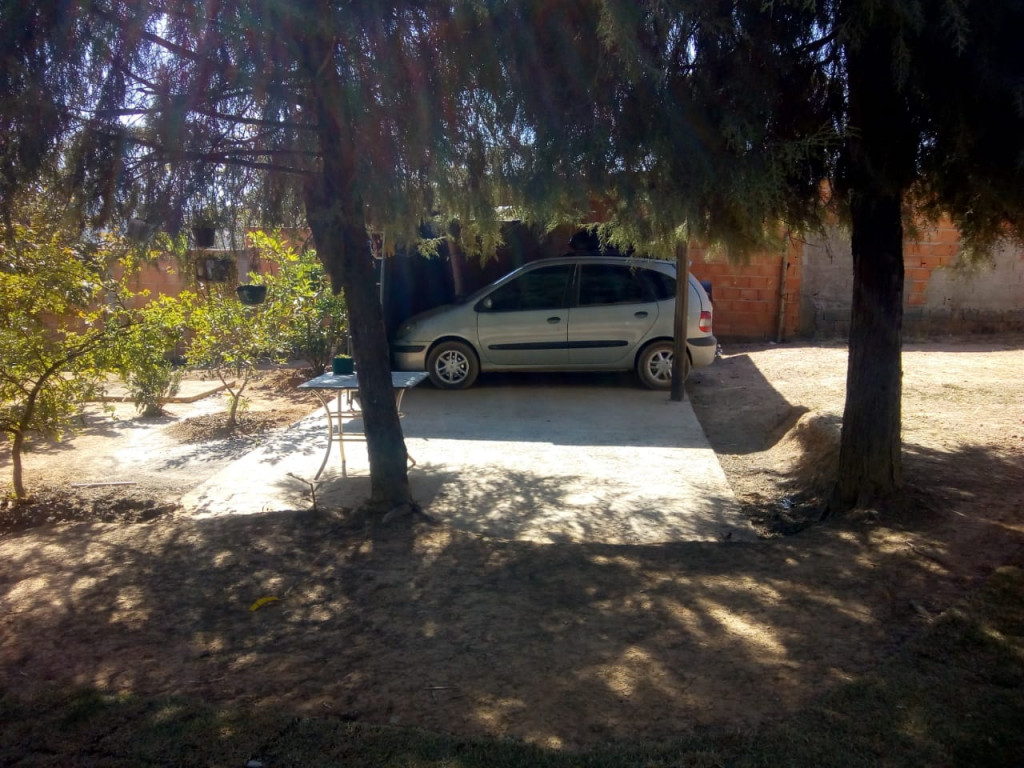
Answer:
[0, 194, 132, 500]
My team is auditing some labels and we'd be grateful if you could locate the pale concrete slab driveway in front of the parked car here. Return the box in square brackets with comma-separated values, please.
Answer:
[185, 376, 756, 544]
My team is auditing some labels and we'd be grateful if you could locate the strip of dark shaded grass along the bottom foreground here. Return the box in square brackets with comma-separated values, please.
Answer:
[0, 566, 1024, 768]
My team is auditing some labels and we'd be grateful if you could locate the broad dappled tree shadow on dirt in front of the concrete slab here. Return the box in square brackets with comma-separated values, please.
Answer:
[0, 454, 1019, 746]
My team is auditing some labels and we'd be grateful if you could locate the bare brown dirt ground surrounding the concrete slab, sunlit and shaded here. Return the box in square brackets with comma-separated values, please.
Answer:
[0, 337, 1024, 749]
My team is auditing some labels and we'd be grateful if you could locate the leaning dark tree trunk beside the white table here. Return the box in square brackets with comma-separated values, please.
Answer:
[305, 27, 415, 512]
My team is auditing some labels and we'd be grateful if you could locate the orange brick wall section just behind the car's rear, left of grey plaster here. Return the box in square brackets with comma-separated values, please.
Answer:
[690, 241, 803, 339]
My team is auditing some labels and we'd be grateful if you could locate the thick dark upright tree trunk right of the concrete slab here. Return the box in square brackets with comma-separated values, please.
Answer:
[827, 22, 913, 513]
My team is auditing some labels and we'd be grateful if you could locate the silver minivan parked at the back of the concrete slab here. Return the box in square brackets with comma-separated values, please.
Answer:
[391, 255, 717, 389]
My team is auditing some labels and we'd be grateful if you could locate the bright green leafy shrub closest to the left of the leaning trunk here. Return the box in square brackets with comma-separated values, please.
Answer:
[250, 231, 348, 375]
